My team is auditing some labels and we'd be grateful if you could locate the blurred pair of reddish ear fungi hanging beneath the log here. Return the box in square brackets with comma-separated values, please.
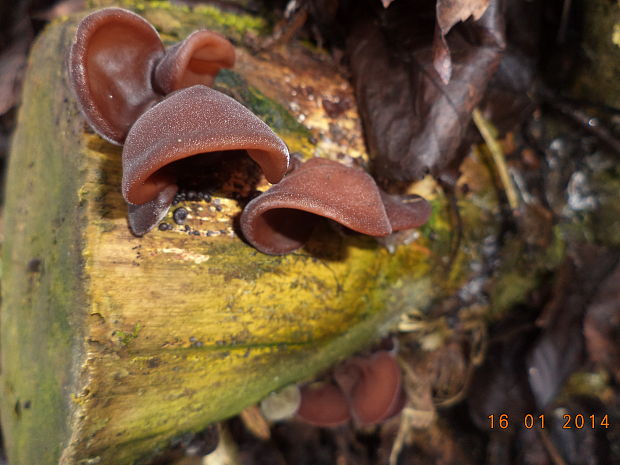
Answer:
[297, 350, 406, 426]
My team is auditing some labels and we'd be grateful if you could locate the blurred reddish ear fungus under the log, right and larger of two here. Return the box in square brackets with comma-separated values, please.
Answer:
[334, 351, 403, 425]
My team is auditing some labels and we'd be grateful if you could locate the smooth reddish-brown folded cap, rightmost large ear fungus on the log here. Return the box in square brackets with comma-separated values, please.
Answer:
[241, 158, 392, 255]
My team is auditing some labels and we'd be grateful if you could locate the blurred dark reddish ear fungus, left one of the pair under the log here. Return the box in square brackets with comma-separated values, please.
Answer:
[297, 383, 351, 426]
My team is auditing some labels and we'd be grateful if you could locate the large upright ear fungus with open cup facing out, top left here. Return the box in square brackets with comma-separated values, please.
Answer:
[69, 8, 164, 144]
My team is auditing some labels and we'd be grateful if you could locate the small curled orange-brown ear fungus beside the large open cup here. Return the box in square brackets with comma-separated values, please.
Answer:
[154, 30, 235, 94]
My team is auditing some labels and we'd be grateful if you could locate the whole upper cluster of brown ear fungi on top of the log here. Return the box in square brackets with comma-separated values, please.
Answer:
[69, 8, 430, 246]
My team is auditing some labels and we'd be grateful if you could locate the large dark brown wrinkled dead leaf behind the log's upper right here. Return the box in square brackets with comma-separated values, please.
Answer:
[347, 0, 504, 181]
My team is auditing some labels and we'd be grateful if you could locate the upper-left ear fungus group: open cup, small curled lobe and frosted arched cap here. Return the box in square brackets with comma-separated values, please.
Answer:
[69, 8, 289, 236]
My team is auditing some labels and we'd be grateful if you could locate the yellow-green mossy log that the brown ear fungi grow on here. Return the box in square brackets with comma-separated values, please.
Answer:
[1, 2, 616, 465]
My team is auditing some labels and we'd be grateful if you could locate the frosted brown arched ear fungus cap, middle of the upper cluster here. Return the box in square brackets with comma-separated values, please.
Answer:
[122, 85, 289, 204]
